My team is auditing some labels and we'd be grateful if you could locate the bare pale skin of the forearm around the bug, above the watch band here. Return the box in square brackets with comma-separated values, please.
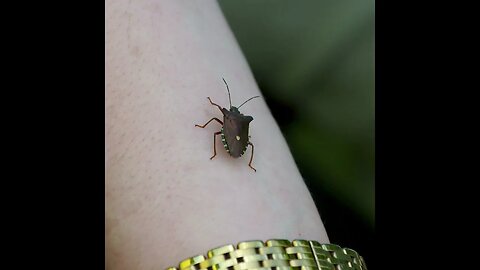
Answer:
[105, 0, 329, 269]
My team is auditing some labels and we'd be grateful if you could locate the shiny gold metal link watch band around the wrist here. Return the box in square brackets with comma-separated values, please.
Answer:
[167, 240, 367, 270]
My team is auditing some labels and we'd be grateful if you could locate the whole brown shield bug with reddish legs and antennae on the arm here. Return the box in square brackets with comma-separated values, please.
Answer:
[195, 78, 260, 172]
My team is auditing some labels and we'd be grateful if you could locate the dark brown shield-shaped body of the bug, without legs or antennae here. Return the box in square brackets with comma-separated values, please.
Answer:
[222, 107, 253, 158]
